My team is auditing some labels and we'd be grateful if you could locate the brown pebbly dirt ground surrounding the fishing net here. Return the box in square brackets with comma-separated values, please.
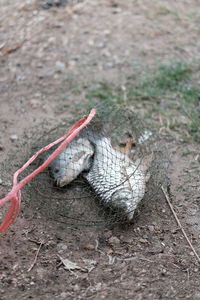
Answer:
[0, 0, 200, 300]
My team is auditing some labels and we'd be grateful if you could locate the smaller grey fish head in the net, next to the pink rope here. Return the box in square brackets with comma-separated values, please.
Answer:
[49, 139, 94, 187]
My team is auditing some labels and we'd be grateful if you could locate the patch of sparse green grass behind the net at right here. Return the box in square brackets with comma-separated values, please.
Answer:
[87, 62, 200, 142]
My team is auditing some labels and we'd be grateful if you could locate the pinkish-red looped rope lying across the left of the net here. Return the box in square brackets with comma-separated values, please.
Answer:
[0, 108, 96, 232]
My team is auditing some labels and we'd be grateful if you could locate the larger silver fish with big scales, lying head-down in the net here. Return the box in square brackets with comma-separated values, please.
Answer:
[85, 137, 146, 220]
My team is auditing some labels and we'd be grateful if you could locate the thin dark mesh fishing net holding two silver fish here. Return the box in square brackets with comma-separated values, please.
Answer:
[1, 105, 169, 226]
